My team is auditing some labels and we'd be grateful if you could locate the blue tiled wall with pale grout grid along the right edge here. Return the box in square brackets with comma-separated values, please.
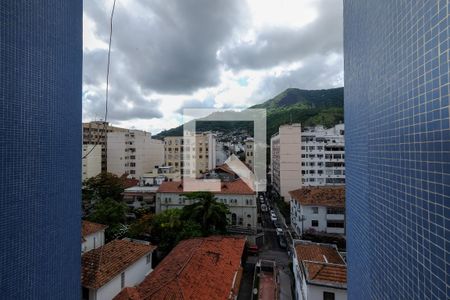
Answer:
[344, 0, 450, 299]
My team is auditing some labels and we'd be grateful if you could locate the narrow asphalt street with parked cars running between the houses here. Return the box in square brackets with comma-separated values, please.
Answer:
[238, 192, 293, 300]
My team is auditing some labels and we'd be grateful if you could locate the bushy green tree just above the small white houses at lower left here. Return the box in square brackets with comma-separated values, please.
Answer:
[87, 198, 128, 241]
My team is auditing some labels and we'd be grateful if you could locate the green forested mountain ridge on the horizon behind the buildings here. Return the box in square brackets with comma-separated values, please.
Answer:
[155, 87, 344, 140]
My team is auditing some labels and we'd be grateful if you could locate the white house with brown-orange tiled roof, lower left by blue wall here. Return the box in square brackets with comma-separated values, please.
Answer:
[81, 239, 156, 300]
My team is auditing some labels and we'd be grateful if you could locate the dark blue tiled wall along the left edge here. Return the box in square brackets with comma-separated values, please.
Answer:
[0, 0, 83, 300]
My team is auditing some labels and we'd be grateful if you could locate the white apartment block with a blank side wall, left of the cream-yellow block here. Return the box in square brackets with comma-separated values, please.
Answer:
[107, 130, 164, 178]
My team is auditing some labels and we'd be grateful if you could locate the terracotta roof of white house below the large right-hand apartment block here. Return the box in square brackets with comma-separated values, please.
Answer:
[289, 186, 345, 207]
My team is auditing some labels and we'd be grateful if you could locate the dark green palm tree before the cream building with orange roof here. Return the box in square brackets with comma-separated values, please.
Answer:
[183, 192, 230, 235]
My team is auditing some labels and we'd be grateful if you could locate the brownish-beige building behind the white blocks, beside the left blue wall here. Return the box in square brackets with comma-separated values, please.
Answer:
[83, 121, 128, 172]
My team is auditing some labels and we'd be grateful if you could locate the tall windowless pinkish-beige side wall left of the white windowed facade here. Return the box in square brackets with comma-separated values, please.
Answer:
[270, 124, 301, 201]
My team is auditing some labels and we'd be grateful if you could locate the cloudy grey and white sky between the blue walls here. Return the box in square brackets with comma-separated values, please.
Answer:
[83, 0, 343, 134]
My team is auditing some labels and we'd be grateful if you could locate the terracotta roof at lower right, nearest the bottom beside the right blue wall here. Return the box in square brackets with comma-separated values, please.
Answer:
[295, 241, 347, 288]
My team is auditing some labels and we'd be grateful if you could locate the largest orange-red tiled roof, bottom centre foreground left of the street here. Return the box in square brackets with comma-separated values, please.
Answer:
[114, 236, 245, 300]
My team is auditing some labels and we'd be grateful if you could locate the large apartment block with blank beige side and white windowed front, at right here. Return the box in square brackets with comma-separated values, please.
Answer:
[270, 124, 345, 201]
